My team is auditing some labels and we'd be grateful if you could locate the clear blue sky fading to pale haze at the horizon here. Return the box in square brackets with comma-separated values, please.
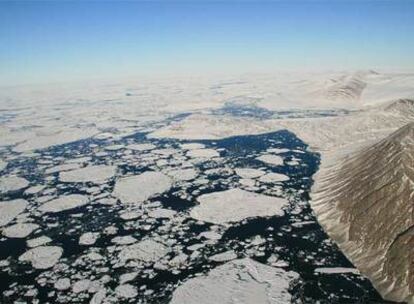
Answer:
[0, 0, 414, 86]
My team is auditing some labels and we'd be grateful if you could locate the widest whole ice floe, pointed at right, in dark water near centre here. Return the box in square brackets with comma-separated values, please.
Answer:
[190, 189, 287, 224]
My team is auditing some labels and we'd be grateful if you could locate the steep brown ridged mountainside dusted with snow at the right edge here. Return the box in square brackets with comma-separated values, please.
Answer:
[312, 122, 414, 303]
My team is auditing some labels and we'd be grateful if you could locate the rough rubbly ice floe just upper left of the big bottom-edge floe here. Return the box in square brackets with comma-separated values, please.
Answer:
[118, 239, 169, 262]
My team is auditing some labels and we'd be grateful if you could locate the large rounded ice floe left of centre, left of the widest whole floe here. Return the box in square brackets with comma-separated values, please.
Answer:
[112, 172, 172, 204]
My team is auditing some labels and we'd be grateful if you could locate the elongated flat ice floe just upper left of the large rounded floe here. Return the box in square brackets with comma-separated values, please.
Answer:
[59, 165, 116, 183]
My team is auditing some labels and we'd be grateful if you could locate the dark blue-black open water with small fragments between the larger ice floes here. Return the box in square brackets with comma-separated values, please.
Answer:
[0, 114, 398, 304]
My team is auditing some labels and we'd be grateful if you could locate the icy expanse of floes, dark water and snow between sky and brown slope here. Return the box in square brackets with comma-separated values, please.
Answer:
[0, 71, 414, 303]
